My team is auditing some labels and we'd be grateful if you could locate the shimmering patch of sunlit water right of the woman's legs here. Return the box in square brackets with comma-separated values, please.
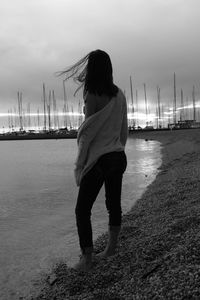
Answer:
[122, 139, 161, 213]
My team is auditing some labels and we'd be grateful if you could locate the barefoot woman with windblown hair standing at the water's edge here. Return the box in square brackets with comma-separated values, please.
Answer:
[59, 50, 128, 271]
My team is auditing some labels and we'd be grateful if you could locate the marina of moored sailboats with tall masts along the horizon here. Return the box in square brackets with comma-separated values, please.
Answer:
[0, 73, 200, 137]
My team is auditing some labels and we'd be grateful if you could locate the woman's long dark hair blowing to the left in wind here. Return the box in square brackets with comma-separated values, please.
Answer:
[58, 49, 118, 97]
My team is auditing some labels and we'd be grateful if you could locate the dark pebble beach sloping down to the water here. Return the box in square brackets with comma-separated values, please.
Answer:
[31, 129, 200, 300]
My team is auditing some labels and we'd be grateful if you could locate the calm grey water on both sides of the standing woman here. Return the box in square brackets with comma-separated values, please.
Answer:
[0, 138, 161, 300]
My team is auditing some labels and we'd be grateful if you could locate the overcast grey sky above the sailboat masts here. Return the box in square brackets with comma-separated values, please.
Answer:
[0, 0, 200, 112]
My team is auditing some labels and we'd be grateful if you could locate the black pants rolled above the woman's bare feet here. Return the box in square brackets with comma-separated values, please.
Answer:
[75, 151, 127, 252]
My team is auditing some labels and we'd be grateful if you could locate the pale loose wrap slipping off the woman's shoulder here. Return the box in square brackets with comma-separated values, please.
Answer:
[74, 90, 127, 186]
